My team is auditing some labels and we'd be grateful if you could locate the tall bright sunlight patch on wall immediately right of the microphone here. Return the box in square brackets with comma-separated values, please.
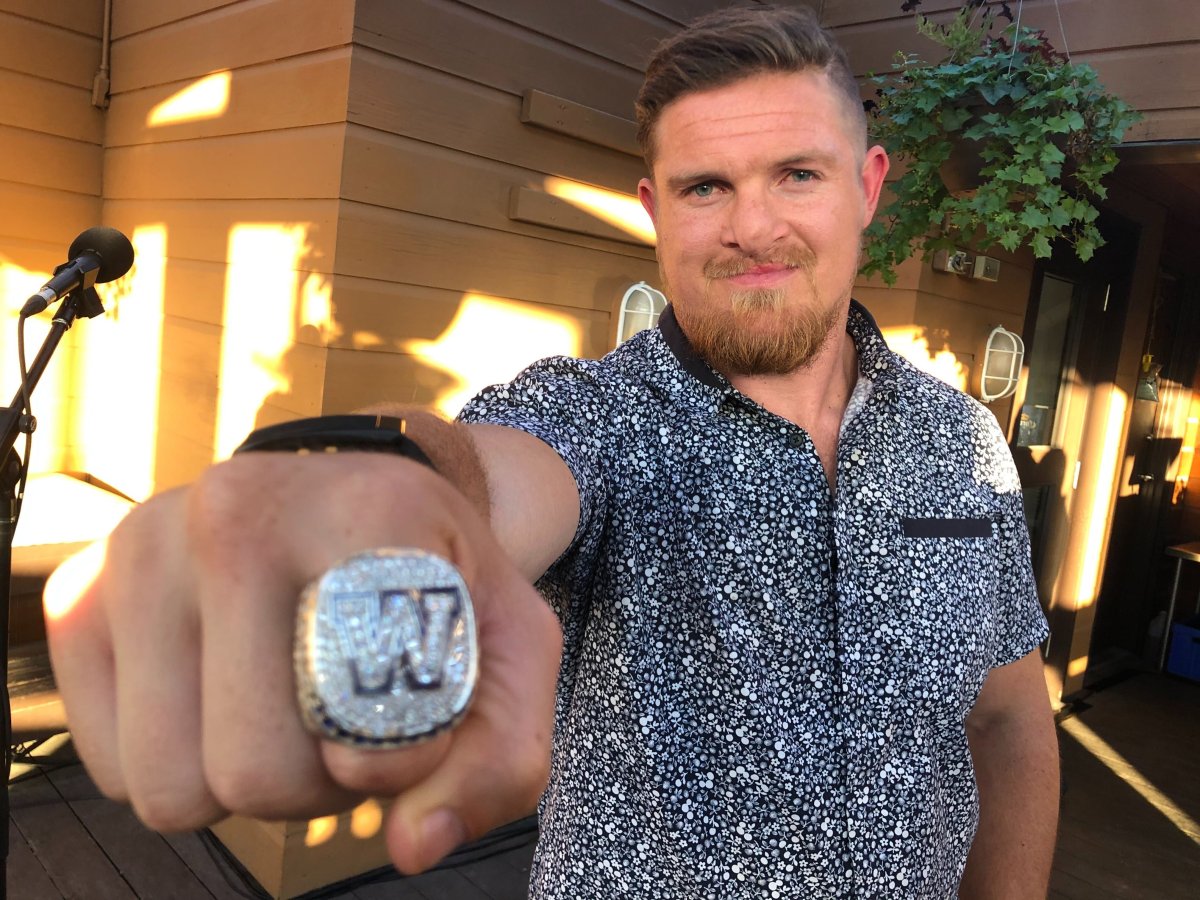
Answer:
[78, 224, 167, 500]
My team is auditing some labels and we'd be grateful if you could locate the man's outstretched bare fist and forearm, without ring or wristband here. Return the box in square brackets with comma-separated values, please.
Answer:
[46, 414, 578, 871]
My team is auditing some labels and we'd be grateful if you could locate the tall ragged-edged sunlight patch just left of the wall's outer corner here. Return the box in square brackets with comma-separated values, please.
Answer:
[214, 224, 319, 460]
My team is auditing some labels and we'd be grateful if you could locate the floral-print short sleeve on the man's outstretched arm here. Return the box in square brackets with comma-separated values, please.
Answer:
[458, 356, 616, 566]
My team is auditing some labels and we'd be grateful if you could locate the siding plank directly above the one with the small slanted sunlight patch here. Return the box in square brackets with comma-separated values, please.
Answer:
[111, 0, 353, 94]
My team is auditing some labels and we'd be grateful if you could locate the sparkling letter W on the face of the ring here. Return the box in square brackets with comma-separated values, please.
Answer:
[332, 587, 462, 697]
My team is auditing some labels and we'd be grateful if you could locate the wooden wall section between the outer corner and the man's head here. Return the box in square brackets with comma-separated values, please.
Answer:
[325, 0, 719, 413]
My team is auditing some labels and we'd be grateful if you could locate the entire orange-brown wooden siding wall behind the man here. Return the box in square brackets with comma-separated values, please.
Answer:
[0, 0, 1200, 497]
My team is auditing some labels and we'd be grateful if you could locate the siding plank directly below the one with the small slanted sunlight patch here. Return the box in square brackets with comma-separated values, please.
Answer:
[104, 124, 344, 200]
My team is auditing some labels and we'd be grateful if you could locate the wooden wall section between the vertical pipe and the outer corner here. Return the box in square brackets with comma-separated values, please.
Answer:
[82, 0, 354, 497]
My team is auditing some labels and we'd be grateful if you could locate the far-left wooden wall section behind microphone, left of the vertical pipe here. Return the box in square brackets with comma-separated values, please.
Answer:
[0, 0, 104, 472]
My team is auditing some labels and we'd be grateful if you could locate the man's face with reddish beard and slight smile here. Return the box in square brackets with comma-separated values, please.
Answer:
[638, 70, 888, 374]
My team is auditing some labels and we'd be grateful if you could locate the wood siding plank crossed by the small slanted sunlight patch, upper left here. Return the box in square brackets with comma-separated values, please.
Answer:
[104, 47, 350, 148]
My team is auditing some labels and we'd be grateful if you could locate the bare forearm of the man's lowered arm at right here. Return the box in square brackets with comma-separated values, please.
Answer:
[959, 700, 1058, 900]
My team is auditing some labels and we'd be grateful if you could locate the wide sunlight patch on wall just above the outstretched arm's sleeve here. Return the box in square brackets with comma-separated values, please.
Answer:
[402, 294, 582, 416]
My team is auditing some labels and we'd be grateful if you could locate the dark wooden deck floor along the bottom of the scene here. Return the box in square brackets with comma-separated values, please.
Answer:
[8, 674, 1200, 900]
